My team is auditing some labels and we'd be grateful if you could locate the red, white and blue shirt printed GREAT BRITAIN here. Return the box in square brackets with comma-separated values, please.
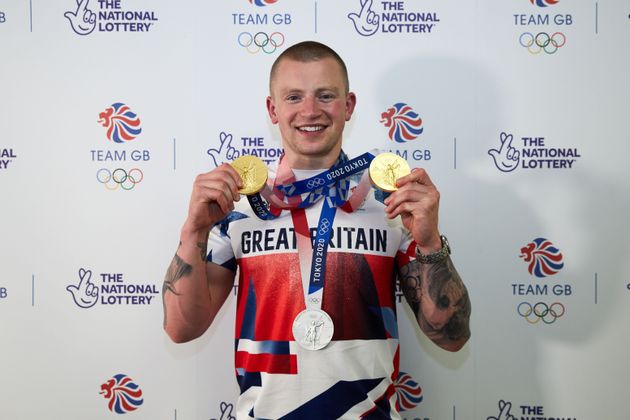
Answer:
[208, 170, 415, 420]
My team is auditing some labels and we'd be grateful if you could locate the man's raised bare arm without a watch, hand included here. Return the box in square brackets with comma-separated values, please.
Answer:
[162, 165, 241, 343]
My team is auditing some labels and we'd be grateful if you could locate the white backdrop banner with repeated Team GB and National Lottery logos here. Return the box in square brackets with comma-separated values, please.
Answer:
[0, 0, 630, 420]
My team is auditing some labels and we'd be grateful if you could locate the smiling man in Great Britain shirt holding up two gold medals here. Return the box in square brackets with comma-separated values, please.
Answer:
[163, 41, 470, 419]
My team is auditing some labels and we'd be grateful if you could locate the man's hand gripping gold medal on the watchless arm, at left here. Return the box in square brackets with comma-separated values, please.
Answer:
[185, 163, 243, 232]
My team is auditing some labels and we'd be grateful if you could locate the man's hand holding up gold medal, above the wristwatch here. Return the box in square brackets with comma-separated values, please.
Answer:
[384, 168, 442, 254]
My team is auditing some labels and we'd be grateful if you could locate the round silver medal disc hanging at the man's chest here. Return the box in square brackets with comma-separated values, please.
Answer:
[293, 309, 335, 350]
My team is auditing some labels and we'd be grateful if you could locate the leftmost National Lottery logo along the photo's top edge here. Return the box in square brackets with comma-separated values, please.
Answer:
[64, 0, 158, 35]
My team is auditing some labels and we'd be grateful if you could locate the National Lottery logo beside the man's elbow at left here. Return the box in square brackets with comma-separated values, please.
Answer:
[66, 268, 159, 309]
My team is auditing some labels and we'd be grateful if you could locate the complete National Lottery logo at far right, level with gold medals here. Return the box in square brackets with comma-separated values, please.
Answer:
[488, 132, 582, 172]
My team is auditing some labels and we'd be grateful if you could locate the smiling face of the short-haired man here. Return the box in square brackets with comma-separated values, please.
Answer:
[267, 58, 356, 169]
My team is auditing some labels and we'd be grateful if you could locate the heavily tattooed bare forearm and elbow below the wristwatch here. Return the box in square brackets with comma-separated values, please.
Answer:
[398, 258, 471, 344]
